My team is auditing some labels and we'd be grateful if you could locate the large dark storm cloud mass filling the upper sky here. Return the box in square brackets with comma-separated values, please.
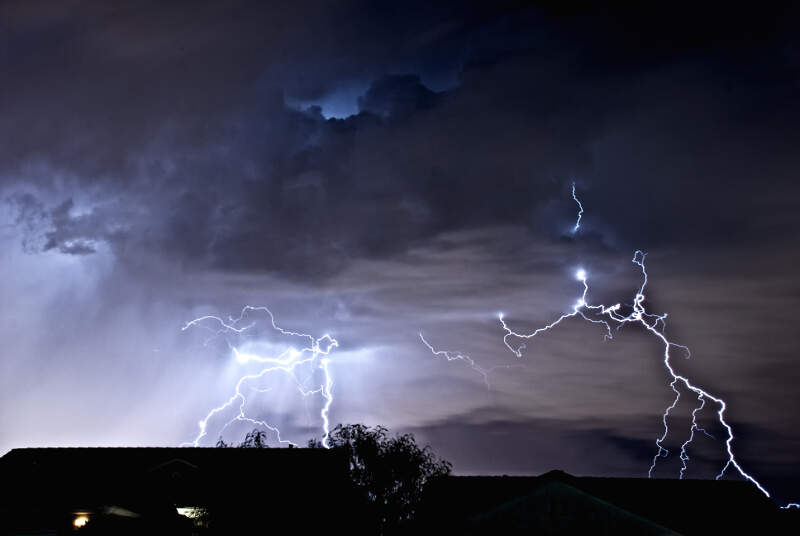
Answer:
[6, 2, 800, 277]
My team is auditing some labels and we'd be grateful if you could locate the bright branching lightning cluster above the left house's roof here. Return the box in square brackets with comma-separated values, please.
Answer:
[183, 305, 339, 448]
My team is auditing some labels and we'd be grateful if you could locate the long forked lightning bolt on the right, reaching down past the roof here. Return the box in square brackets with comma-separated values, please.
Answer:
[500, 250, 800, 502]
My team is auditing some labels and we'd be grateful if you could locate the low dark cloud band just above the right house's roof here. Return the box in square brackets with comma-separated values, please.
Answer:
[411, 400, 797, 496]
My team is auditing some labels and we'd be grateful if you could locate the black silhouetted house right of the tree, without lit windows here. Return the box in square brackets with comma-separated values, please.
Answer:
[418, 471, 800, 535]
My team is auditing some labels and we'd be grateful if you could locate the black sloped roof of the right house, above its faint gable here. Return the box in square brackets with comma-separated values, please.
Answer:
[421, 471, 788, 534]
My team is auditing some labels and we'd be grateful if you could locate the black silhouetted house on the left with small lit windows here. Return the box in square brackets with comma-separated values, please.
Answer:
[0, 448, 358, 534]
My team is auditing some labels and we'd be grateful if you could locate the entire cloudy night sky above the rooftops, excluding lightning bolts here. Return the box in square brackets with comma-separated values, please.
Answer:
[0, 0, 800, 502]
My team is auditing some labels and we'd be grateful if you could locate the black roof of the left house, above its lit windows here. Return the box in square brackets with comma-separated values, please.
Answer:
[0, 447, 349, 505]
